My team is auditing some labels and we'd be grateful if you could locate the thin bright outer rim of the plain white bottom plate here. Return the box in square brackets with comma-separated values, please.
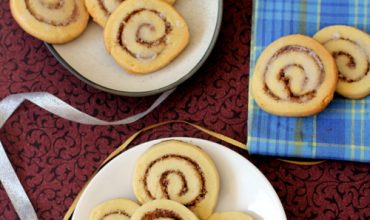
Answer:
[71, 136, 287, 220]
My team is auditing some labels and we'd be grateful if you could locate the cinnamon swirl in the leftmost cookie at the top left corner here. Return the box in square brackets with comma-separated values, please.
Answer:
[25, 0, 78, 26]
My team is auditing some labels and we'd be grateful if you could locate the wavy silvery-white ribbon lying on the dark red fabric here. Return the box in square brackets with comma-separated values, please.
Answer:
[0, 88, 176, 220]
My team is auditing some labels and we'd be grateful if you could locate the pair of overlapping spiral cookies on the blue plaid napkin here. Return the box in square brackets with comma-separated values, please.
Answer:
[251, 26, 370, 116]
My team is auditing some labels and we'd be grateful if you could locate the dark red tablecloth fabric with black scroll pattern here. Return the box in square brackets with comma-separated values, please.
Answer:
[0, 0, 370, 219]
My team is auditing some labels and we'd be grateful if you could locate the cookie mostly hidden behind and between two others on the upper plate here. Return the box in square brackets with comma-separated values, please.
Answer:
[85, 0, 175, 27]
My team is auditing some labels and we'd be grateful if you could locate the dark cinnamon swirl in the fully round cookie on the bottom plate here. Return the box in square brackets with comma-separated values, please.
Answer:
[143, 154, 207, 207]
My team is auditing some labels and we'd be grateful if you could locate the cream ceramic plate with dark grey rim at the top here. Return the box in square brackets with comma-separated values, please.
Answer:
[47, 0, 222, 96]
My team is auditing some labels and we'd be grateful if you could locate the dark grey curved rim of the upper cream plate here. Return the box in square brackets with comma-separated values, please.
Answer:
[44, 0, 223, 97]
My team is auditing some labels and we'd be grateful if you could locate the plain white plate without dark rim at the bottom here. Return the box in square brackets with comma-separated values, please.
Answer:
[72, 137, 286, 220]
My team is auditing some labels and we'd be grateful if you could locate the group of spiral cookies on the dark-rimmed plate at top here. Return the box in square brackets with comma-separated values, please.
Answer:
[10, 0, 189, 74]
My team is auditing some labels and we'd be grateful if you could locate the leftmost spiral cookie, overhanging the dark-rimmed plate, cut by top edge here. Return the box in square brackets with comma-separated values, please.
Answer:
[10, 0, 89, 44]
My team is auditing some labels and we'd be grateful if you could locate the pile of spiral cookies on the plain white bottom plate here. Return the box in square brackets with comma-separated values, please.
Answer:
[90, 140, 252, 220]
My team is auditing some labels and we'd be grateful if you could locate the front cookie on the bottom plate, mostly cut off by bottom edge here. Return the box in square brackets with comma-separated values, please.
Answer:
[131, 199, 198, 220]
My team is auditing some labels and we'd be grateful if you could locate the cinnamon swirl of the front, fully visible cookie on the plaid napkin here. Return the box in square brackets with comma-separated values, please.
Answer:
[263, 45, 325, 103]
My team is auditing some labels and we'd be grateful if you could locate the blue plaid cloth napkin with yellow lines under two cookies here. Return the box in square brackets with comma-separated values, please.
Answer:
[247, 0, 370, 162]
